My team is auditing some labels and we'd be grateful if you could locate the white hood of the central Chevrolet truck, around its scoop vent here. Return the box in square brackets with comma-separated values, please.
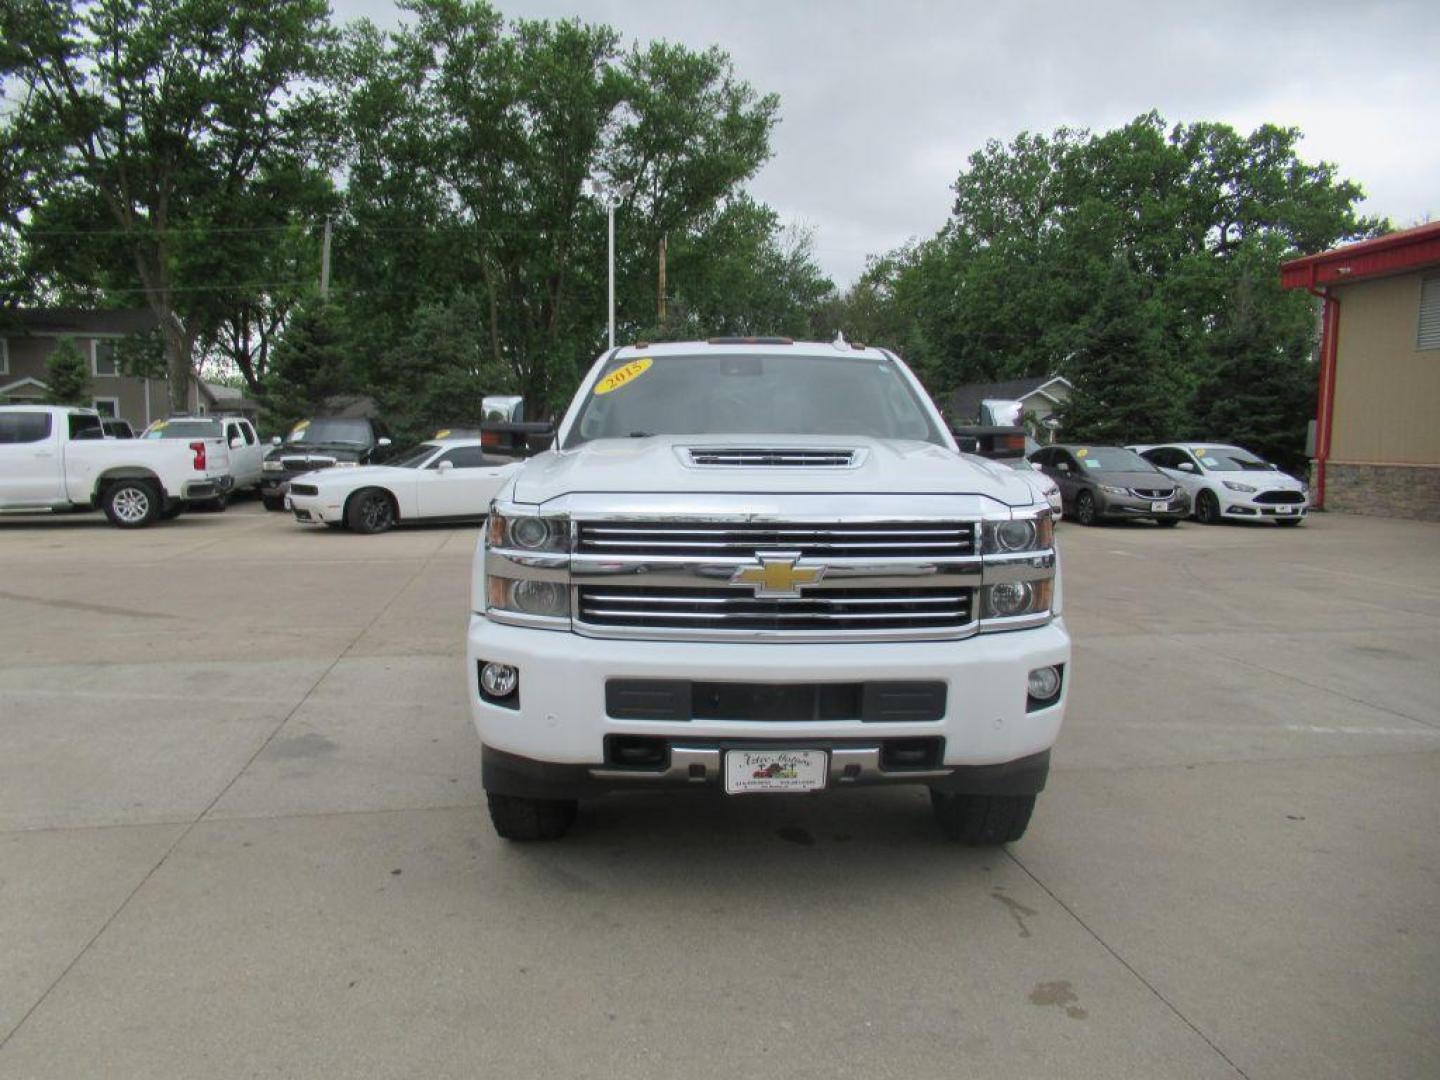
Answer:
[514, 435, 1037, 507]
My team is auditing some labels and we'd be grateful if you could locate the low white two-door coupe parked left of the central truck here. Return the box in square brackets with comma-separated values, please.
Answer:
[285, 438, 520, 533]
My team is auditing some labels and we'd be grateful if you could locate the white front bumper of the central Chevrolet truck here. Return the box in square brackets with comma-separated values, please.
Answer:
[467, 615, 1070, 788]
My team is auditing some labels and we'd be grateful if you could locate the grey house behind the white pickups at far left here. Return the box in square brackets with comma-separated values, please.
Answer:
[0, 308, 259, 431]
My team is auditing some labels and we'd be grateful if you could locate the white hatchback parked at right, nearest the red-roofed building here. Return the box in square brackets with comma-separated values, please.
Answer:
[1130, 442, 1310, 526]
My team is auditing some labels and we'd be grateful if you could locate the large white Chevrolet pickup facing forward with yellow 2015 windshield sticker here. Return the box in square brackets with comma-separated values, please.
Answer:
[467, 338, 1070, 844]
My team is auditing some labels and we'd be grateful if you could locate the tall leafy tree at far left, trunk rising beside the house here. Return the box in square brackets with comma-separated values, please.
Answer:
[0, 0, 330, 409]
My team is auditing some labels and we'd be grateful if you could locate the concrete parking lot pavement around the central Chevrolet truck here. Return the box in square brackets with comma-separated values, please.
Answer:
[0, 504, 1440, 1080]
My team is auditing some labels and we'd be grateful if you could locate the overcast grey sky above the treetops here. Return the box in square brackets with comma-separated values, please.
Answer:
[331, 0, 1440, 285]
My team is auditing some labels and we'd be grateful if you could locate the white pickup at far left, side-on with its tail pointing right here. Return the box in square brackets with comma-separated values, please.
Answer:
[0, 405, 232, 528]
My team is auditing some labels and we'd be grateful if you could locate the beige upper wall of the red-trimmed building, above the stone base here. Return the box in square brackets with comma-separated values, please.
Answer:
[1331, 268, 1440, 465]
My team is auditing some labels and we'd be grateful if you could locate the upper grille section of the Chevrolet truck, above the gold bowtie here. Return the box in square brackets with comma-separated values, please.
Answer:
[576, 521, 975, 557]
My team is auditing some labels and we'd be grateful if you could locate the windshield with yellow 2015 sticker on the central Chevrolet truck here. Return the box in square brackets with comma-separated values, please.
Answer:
[566, 353, 945, 446]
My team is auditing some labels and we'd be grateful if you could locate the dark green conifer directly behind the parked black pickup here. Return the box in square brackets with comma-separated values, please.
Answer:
[264, 300, 353, 428]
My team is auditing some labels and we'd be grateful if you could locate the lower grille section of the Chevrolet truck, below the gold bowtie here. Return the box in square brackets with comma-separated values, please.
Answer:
[576, 583, 975, 634]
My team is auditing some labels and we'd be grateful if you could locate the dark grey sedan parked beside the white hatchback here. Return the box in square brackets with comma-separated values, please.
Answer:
[1030, 446, 1189, 526]
